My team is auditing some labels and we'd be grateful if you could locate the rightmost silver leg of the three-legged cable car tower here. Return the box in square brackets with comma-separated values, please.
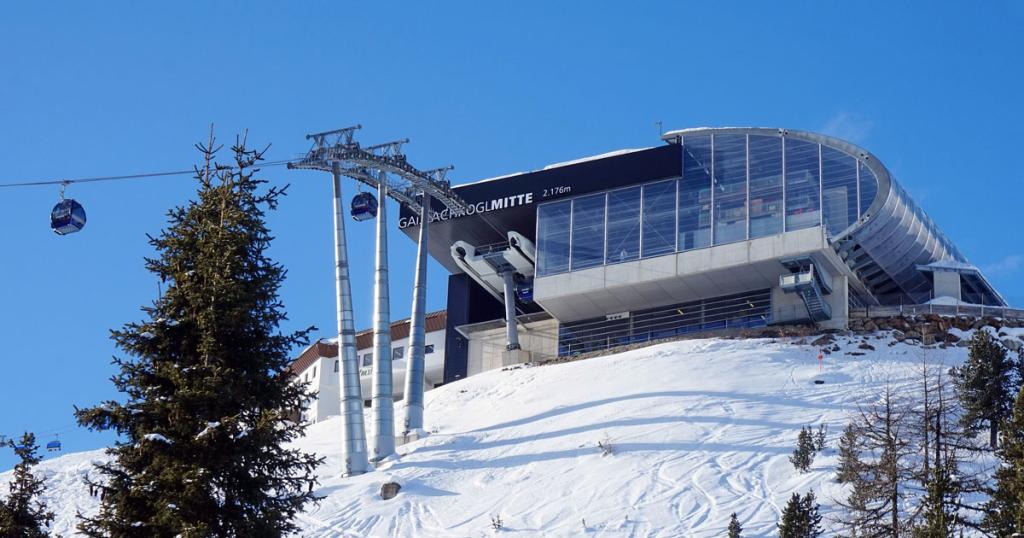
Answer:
[402, 193, 430, 437]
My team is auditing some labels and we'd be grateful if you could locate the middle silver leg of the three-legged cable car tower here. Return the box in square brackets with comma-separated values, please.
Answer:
[372, 172, 394, 461]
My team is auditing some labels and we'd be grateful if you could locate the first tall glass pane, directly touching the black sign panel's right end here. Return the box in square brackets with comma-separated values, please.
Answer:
[679, 135, 711, 250]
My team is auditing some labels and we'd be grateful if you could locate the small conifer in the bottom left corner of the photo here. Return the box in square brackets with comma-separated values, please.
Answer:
[0, 432, 53, 538]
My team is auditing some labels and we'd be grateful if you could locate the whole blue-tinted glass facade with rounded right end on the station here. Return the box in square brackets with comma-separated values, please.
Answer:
[537, 132, 878, 277]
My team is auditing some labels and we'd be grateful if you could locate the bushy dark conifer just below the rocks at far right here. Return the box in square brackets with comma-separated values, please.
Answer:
[950, 330, 1021, 450]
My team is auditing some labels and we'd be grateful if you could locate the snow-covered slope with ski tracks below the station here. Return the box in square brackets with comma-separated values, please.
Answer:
[0, 335, 987, 537]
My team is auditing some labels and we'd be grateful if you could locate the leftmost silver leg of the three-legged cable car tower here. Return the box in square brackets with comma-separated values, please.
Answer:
[332, 163, 370, 477]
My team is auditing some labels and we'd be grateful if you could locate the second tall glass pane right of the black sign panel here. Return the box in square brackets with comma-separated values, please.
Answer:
[714, 134, 746, 245]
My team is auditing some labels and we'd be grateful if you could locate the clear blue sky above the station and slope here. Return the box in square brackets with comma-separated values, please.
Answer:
[0, 1, 1024, 468]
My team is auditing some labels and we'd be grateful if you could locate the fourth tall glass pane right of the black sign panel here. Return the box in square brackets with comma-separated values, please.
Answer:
[785, 138, 821, 232]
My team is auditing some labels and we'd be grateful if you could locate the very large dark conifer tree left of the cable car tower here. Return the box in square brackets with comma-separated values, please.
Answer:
[76, 134, 321, 538]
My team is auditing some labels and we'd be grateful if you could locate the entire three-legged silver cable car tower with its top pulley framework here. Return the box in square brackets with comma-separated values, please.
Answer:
[288, 125, 467, 469]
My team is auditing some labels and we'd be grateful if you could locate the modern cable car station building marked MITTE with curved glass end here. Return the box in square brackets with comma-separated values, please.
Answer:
[399, 128, 1006, 382]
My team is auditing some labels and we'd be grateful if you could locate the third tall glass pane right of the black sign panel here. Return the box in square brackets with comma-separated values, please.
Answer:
[750, 134, 782, 239]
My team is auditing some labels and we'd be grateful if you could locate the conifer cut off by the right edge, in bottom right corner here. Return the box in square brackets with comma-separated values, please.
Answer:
[983, 388, 1024, 538]
